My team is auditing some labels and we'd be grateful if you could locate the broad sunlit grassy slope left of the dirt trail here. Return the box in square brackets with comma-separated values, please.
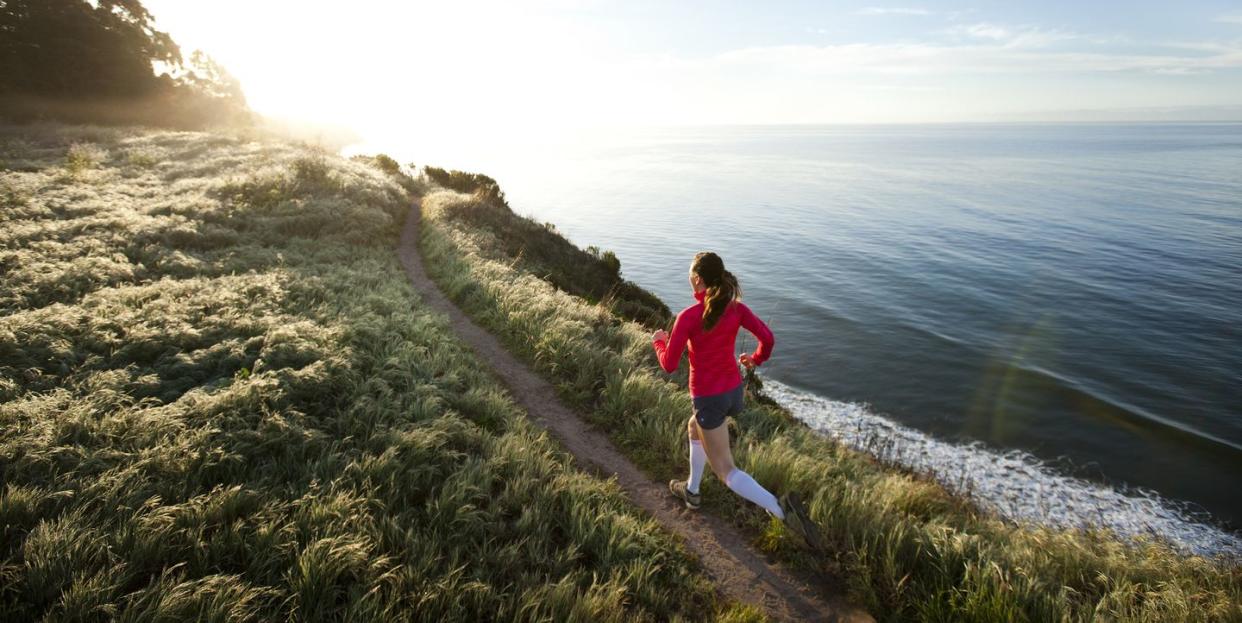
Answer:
[0, 125, 749, 621]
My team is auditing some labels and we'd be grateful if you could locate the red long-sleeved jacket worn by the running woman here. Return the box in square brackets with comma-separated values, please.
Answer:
[651, 290, 776, 396]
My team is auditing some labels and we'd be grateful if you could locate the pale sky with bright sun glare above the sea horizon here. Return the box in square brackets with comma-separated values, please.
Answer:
[144, 0, 1242, 134]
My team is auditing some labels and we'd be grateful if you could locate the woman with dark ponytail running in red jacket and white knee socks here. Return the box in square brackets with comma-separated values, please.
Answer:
[651, 252, 805, 541]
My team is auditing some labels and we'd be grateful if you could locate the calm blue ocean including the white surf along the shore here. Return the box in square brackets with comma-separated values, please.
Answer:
[377, 124, 1242, 554]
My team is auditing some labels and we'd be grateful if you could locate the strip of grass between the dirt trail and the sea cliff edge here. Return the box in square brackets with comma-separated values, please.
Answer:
[422, 182, 1242, 622]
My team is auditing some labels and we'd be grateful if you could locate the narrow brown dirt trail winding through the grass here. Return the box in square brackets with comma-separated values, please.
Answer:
[397, 202, 873, 622]
